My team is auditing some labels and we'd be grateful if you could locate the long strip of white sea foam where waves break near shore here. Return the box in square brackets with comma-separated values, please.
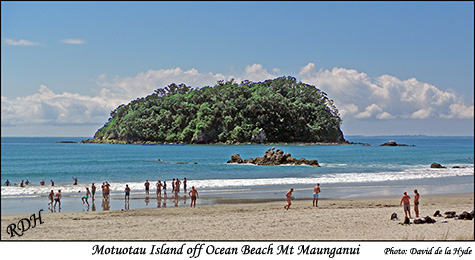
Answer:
[1, 165, 474, 198]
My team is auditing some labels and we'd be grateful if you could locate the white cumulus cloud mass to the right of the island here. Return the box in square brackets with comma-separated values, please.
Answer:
[299, 63, 474, 119]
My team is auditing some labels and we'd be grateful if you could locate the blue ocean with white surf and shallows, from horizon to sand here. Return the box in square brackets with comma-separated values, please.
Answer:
[1, 136, 474, 212]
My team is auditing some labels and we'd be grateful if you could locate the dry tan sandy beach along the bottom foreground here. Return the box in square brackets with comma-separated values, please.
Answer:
[1, 193, 474, 241]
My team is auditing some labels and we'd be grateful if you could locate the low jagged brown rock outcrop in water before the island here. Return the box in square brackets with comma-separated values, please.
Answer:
[228, 147, 320, 167]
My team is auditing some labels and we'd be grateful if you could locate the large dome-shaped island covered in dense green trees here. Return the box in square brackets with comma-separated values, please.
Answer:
[83, 77, 345, 144]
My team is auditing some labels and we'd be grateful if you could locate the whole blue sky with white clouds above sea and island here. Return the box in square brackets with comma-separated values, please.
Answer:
[1, 2, 474, 137]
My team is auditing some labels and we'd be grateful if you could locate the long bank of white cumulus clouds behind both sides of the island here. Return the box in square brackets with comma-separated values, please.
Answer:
[1, 63, 474, 130]
